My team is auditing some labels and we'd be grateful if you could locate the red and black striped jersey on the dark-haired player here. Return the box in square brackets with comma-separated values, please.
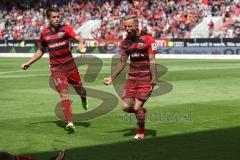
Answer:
[40, 25, 77, 70]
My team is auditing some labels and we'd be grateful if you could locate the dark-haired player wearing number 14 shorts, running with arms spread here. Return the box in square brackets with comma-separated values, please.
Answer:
[21, 8, 88, 132]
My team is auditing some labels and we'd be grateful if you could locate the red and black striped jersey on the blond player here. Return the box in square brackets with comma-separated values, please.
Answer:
[121, 32, 157, 81]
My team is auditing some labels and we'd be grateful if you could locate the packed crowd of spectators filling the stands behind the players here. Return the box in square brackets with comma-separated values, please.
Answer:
[0, 0, 240, 40]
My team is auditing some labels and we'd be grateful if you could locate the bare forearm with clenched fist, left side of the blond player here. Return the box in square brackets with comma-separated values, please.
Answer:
[103, 55, 128, 85]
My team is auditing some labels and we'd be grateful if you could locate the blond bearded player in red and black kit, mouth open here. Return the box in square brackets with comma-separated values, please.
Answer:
[103, 16, 157, 139]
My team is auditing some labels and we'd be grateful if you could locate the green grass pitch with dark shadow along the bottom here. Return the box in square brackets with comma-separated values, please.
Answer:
[0, 58, 240, 160]
